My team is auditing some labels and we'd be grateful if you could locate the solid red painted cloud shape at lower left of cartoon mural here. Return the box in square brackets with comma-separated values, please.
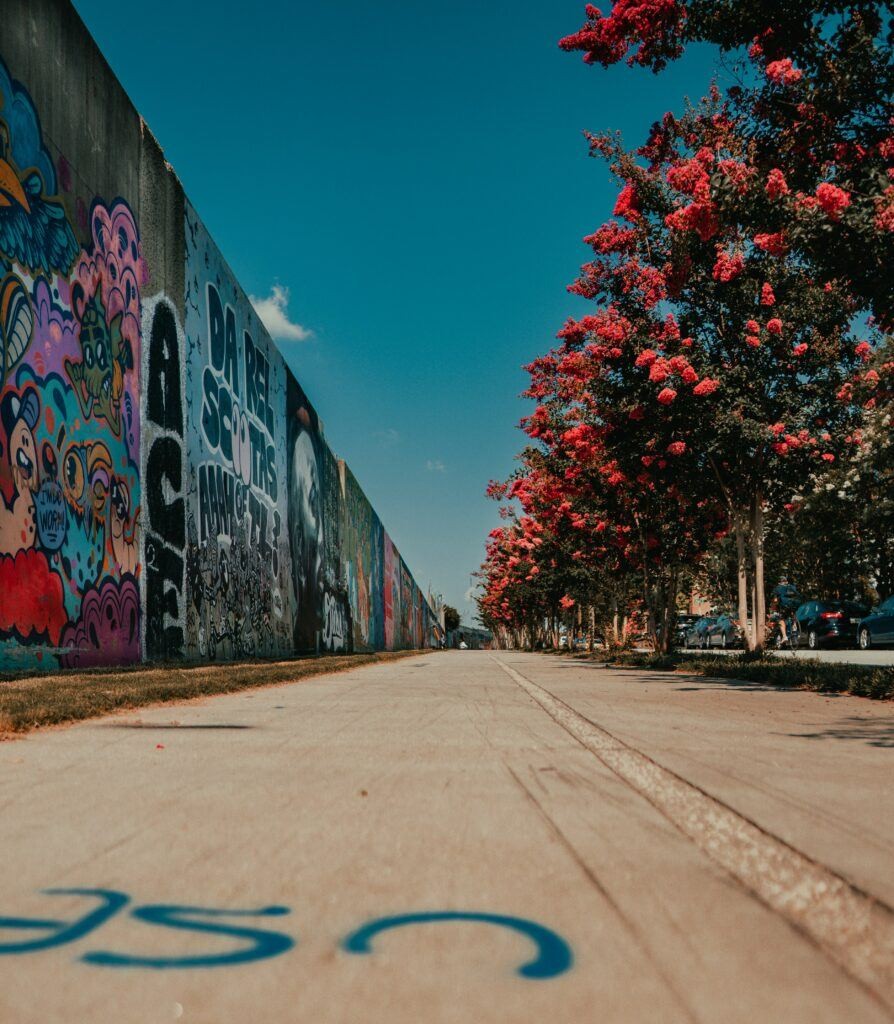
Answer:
[0, 548, 68, 644]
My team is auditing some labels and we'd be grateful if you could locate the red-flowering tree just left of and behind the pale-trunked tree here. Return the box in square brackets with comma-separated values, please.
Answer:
[522, 296, 724, 650]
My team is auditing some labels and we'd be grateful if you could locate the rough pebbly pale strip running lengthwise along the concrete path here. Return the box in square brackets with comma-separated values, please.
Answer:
[492, 655, 894, 1011]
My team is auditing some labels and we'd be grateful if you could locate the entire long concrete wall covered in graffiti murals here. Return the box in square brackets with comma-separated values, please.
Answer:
[0, 0, 439, 670]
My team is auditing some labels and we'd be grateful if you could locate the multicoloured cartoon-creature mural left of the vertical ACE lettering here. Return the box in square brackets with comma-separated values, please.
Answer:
[0, 62, 146, 668]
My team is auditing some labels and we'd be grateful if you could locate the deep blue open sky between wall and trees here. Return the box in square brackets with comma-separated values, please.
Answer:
[75, 0, 713, 621]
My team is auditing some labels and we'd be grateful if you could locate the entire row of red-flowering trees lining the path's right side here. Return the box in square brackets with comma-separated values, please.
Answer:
[481, 0, 894, 650]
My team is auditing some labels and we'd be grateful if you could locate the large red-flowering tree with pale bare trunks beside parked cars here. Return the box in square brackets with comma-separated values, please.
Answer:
[540, 90, 878, 649]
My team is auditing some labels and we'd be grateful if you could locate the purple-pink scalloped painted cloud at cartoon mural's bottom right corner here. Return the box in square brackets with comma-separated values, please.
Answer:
[60, 578, 139, 669]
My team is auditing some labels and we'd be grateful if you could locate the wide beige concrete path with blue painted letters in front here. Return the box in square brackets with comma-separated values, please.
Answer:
[0, 651, 894, 1024]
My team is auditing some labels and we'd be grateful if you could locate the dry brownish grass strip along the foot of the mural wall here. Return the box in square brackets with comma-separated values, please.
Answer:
[0, 650, 434, 739]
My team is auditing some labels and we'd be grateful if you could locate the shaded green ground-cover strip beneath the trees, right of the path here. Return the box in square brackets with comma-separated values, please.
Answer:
[561, 651, 894, 700]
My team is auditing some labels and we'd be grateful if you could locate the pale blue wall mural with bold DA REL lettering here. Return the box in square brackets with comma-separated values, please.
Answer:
[184, 204, 292, 658]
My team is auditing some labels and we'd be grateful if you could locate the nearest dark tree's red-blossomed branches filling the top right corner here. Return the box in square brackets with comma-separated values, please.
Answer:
[559, 0, 894, 327]
